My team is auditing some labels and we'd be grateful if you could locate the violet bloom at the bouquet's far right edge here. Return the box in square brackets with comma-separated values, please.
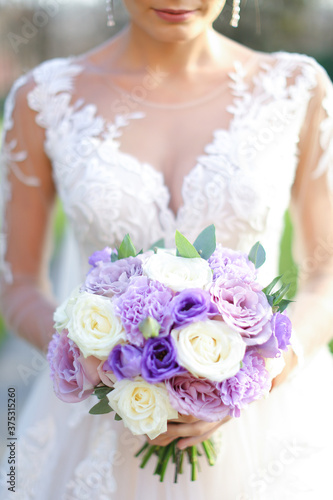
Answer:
[252, 312, 292, 358]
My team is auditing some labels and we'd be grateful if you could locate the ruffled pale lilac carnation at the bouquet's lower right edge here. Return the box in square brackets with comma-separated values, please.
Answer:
[217, 351, 270, 417]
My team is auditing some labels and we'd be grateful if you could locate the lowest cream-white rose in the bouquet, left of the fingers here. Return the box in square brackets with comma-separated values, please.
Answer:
[107, 377, 178, 439]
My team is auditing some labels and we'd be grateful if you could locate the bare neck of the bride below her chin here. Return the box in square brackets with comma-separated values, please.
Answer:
[107, 24, 222, 74]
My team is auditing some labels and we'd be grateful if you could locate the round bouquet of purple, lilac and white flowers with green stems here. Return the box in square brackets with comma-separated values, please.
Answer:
[48, 225, 291, 482]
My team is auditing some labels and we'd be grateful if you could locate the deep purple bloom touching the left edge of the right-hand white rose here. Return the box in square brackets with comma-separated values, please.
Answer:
[141, 335, 185, 384]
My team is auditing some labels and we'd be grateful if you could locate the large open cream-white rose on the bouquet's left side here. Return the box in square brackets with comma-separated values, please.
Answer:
[67, 292, 126, 359]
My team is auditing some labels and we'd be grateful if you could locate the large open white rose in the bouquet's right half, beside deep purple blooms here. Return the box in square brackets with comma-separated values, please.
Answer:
[171, 320, 246, 382]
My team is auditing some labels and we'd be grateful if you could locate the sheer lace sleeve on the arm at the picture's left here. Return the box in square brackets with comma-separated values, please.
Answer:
[0, 77, 55, 349]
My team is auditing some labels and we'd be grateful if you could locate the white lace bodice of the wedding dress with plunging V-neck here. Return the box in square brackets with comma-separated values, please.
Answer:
[1, 53, 332, 286]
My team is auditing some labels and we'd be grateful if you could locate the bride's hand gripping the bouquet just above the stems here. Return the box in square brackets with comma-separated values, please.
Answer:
[148, 415, 231, 449]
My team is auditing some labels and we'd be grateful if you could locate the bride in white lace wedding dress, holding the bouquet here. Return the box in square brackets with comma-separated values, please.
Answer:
[0, 0, 333, 500]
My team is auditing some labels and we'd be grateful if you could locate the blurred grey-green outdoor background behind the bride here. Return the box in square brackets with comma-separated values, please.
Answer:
[0, 0, 333, 451]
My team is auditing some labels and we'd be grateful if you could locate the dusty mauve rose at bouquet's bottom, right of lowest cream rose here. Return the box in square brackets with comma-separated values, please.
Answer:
[165, 372, 229, 422]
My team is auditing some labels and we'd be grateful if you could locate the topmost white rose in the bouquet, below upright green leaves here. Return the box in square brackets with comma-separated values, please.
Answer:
[143, 251, 213, 292]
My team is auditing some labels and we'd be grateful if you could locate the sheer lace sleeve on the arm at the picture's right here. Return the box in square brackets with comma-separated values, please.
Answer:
[291, 59, 333, 355]
